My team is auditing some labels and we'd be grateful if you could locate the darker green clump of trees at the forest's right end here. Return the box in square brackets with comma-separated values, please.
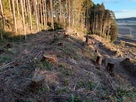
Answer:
[90, 3, 117, 41]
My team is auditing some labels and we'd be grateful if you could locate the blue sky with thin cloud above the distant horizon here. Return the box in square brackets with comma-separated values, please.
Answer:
[93, 0, 136, 18]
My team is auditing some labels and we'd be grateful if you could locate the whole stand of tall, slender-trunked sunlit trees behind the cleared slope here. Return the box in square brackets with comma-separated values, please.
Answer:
[0, 0, 116, 39]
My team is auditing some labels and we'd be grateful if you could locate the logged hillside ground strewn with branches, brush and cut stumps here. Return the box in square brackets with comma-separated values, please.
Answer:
[0, 29, 136, 102]
